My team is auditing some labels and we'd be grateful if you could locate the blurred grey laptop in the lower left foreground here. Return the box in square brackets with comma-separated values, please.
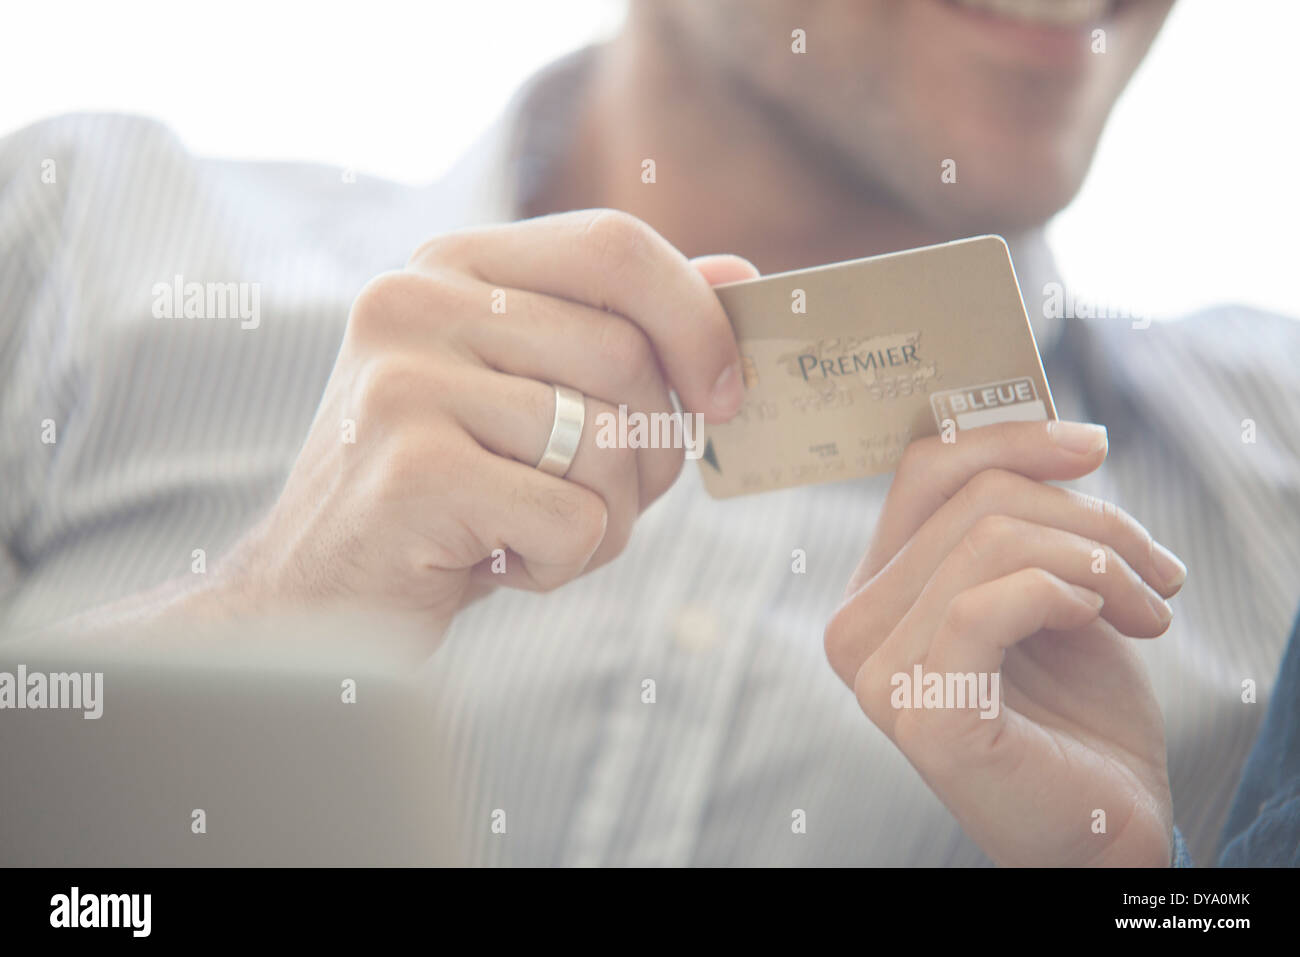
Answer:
[0, 616, 464, 867]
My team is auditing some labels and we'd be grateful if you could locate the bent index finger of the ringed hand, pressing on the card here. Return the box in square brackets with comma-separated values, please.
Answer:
[412, 209, 744, 423]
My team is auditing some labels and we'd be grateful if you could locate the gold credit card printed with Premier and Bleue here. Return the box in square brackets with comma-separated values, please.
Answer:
[699, 235, 1056, 498]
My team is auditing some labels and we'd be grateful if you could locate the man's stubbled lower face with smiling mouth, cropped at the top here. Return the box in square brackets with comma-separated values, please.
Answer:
[641, 0, 1173, 234]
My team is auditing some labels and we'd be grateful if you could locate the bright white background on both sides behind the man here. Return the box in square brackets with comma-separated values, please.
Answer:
[0, 0, 1300, 316]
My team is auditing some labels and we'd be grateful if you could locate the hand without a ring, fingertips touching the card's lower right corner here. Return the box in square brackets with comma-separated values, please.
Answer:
[826, 423, 1186, 866]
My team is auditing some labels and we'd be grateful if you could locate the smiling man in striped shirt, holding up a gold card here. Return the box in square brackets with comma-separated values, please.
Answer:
[0, 0, 1300, 865]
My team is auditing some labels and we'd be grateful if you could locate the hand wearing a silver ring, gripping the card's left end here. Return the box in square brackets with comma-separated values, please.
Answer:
[222, 211, 757, 633]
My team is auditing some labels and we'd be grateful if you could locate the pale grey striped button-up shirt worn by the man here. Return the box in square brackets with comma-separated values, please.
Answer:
[0, 52, 1300, 865]
